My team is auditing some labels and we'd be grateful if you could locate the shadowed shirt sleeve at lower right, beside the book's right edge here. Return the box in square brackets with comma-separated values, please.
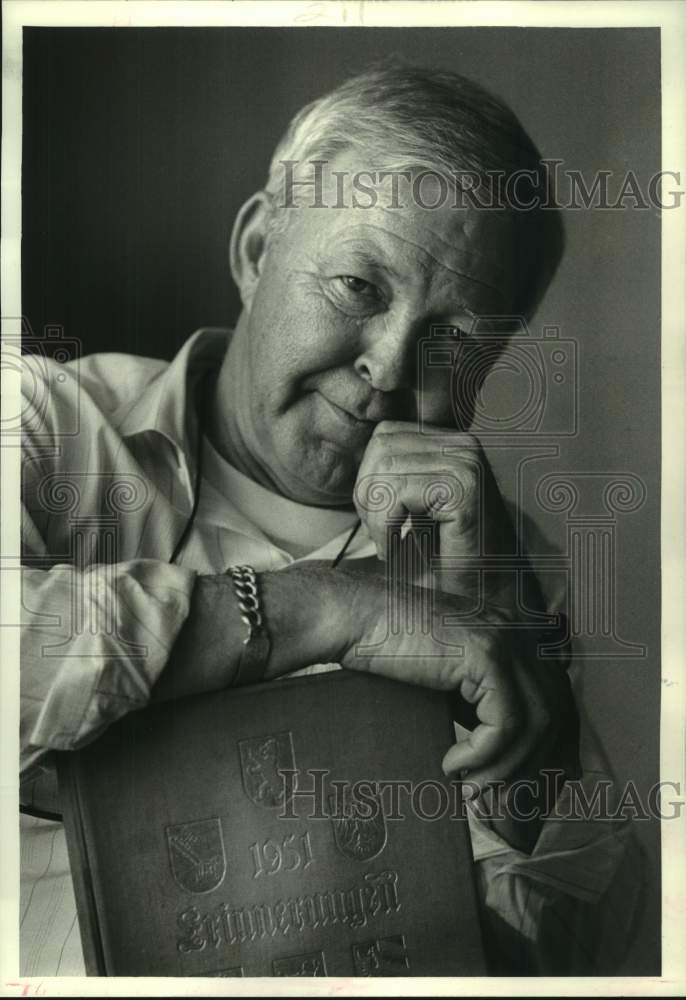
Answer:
[468, 704, 646, 976]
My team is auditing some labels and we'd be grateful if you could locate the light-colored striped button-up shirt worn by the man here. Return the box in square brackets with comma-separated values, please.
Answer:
[21, 329, 633, 976]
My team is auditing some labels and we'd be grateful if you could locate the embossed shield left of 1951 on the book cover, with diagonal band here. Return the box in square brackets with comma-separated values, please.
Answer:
[166, 818, 226, 892]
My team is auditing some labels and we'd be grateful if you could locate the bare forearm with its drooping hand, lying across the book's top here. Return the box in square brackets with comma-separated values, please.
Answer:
[153, 562, 570, 832]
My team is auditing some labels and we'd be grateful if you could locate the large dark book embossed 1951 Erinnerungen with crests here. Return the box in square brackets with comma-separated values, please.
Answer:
[58, 670, 485, 977]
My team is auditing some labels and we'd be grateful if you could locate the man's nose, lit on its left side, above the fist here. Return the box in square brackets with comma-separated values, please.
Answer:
[354, 314, 418, 392]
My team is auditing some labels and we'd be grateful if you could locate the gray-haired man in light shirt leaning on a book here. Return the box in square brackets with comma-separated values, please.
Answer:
[22, 66, 636, 974]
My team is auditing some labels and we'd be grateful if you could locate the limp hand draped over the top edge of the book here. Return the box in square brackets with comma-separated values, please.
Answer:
[342, 578, 578, 791]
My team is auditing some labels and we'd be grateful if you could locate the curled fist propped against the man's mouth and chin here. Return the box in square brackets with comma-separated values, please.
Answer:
[353, 420, 515, 600]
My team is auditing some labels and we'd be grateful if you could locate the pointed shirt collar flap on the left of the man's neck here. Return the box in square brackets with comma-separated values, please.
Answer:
[112, 327, 231, 494]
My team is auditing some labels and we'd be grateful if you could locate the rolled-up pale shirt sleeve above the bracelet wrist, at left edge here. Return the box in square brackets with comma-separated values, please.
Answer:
[21, 559, 195, 776]
